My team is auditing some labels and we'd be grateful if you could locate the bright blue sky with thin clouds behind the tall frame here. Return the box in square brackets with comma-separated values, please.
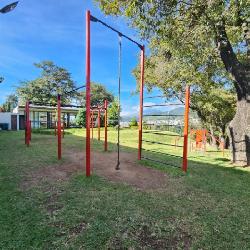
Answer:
[0, 0, 175, 116]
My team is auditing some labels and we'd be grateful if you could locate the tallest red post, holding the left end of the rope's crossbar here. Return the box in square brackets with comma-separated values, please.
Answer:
[86, 10, 90, 176]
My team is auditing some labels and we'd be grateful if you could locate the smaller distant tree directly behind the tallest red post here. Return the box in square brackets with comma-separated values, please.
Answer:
[76, 83, 114, 107]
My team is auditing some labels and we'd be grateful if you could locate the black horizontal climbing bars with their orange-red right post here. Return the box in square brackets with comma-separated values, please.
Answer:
[139, 87, 190, 171]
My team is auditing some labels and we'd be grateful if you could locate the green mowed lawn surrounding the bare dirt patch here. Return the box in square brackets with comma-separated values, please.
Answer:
[0, 129, 250, 249]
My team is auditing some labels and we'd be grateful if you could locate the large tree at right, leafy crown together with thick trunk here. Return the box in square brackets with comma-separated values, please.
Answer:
[97, 0, 250, 165]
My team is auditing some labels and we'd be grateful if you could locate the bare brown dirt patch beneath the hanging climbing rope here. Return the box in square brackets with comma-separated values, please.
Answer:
[23, 149, 167, 190]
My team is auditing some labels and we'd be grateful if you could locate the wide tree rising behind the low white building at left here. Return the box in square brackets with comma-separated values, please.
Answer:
[17, 61, 76, 104]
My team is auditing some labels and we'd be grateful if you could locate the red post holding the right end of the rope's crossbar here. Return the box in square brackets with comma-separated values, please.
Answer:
[138, 46, 145, 160]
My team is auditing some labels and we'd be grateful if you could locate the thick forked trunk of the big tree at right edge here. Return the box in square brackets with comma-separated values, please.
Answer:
[216, 24, 250, 166]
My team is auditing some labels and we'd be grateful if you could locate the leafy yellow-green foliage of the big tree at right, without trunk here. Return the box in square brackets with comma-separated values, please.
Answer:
[97, 0, 246, 135]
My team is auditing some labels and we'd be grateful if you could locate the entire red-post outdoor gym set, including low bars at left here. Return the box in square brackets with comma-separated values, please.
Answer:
[25, 11, 190, 176]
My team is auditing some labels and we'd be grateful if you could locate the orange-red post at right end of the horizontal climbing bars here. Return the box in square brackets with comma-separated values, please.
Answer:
[182, 86, 190, 172]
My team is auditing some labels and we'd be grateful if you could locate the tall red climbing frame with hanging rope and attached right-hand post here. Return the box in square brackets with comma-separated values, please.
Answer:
[86, 11, 190, 176]
